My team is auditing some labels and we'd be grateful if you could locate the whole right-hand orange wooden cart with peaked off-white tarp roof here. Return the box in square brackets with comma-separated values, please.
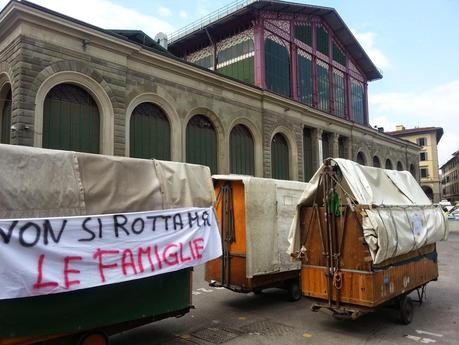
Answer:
[290, 159, 447, 324]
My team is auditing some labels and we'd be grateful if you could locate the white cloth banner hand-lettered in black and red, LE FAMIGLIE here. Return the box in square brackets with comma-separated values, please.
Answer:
[0, 207, 221, 299]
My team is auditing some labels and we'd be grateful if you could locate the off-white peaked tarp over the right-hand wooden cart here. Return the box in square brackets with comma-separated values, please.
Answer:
[288, 158, 448, 264]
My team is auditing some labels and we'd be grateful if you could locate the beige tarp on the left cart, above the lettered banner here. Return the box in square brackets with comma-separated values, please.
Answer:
[0, 145, 215, 218]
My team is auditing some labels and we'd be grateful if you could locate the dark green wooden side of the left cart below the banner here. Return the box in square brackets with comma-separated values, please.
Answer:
[0, 269, 191, 339]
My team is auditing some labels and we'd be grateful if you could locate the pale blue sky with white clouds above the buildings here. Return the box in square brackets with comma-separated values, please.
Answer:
[0, 0, 459, 165]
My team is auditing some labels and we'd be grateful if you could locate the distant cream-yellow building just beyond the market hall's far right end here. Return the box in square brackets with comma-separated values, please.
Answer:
[386, 125, 443, 202]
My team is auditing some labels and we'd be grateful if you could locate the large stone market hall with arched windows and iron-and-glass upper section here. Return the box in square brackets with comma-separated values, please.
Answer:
[0, 0, 419, 180]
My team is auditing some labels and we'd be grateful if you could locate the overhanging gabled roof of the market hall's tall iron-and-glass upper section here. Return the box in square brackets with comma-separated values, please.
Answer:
[169, 0, 382, 80]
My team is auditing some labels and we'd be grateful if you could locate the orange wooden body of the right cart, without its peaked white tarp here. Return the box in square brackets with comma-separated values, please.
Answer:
[295, 160, 450, 324]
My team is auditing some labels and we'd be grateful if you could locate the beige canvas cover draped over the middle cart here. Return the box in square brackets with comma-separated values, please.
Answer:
[212, 175, 308, 278]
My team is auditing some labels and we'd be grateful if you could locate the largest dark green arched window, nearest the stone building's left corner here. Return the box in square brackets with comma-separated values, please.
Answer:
[43, 84, 100, 153]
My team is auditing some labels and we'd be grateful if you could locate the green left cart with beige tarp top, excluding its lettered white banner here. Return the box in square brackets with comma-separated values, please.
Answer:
[0, 145, 215, 345]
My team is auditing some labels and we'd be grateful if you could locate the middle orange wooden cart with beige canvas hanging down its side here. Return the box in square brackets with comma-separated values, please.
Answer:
[206, 175, 306, 300]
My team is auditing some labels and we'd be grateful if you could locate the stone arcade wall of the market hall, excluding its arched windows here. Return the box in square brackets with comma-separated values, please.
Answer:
[0, 2, 419, 180]
